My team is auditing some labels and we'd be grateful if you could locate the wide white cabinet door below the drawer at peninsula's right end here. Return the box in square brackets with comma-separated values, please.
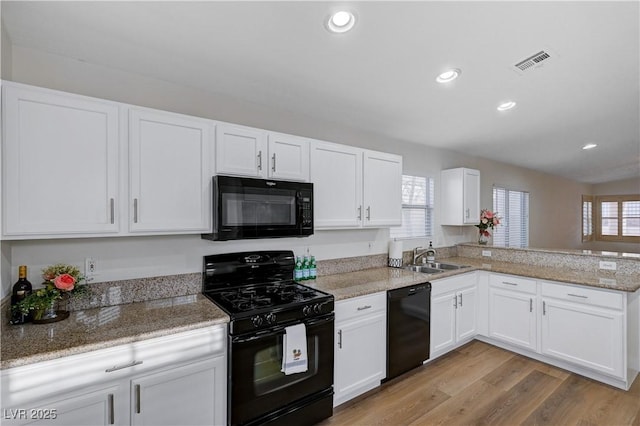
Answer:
[542, 299, 626, 379]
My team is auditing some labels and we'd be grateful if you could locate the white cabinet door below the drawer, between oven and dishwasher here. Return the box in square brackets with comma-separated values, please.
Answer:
[333, 313, 386, 406]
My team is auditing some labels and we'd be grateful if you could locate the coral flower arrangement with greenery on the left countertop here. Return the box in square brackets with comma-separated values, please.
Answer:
[15, 263, 86, 324]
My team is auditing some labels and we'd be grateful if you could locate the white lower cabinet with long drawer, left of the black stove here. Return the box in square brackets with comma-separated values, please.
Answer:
[0, 326, 227, 426]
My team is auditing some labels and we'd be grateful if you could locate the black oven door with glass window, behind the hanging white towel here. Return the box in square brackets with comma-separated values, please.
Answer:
[228, 313, 334, 425]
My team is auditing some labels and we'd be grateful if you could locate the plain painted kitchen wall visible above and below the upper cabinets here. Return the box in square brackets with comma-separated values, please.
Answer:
[2, 46, 591, 290]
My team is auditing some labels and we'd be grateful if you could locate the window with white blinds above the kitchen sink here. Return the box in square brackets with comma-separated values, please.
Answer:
[390, 175, 434, 238]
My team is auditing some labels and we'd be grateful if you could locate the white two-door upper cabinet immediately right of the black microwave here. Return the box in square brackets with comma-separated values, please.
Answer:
[311, 141, 402, 229]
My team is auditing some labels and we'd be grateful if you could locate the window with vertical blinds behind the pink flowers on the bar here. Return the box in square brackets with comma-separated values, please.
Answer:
[493, 186, 529, 247]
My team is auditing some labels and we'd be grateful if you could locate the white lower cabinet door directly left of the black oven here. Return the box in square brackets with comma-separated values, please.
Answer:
[131, 357, 227, 426]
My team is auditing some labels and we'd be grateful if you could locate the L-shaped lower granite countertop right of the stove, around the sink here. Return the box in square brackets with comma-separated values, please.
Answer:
[305, 257, 640, 301]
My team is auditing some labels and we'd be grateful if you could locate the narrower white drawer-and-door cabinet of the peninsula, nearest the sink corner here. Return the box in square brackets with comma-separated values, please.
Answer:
[489, 274, 538, 351]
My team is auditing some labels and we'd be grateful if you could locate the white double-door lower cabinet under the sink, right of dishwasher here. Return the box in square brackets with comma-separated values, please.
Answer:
[430, 272, 478, 358]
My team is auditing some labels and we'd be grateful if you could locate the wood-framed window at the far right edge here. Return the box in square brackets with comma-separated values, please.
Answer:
[596, 195, 640, 243]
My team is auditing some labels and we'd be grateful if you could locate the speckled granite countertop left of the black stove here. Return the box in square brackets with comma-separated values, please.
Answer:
[0, 294, 229, 369]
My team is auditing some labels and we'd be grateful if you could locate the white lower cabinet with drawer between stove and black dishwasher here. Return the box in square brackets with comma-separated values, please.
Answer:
[333, 292, 387, 407]
